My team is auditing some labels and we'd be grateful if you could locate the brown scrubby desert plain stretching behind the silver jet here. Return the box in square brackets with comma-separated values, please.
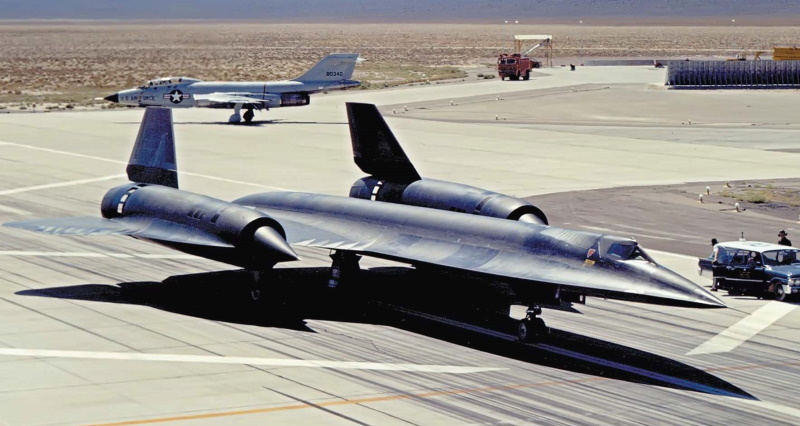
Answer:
[0, 21, 800, 111]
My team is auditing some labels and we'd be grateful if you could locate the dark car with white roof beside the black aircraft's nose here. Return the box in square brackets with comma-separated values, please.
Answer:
[698, 241, 800, 300]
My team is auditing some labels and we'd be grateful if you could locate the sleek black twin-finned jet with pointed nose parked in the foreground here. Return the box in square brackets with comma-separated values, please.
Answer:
[5, 103, 725, 341]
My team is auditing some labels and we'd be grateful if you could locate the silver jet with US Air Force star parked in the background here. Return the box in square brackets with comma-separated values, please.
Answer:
[104, 53, 361, 123]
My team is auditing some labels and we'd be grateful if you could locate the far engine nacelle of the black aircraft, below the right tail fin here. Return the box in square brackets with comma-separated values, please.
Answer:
[350, 176, 548, 225]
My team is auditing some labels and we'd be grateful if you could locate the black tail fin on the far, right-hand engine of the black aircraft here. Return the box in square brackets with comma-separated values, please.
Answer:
[347, 102, 421, 183]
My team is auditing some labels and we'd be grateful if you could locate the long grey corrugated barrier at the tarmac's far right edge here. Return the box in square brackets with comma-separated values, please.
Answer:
[666, 61, 800, 88]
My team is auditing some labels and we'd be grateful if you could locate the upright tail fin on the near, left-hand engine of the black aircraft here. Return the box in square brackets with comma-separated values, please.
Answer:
[125, 107, 178, 188]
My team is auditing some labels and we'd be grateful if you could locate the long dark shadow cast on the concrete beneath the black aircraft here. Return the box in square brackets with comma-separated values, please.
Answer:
[16, 267, 756, 400]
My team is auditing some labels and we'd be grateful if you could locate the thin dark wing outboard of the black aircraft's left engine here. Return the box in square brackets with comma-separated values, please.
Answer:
[4, 216, 233, 247]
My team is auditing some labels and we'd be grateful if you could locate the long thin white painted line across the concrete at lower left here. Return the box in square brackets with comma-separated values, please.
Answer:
[0, 348, 505, 374]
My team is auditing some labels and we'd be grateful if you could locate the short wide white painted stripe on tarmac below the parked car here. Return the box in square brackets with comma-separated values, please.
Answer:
[686, 301, 796, 355]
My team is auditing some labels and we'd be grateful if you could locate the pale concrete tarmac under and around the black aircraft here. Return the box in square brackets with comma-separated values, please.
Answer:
[0, 67, 800, 425]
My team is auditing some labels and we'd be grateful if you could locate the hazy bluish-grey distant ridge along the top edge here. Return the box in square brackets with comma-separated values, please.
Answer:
[0, 0, 800, 22]
